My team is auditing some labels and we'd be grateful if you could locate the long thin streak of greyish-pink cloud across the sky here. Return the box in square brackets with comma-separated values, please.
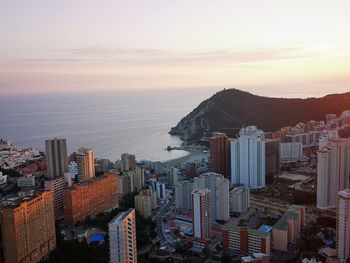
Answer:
[0, 47, 317, 67]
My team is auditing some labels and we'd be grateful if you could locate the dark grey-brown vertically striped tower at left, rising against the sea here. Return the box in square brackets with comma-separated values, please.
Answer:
[45, 138, 68, 178]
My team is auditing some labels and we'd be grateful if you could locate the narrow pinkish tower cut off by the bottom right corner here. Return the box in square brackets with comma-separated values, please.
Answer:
[337, 189, 350, 263]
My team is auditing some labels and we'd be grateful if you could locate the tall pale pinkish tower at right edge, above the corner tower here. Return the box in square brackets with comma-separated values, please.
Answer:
[317, 139, 350, 209]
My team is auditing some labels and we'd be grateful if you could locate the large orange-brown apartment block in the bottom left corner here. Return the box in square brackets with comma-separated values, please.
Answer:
[1, 192, 56, 263]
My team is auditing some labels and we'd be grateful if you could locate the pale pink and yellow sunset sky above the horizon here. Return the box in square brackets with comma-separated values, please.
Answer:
[0, 0, 350, 97]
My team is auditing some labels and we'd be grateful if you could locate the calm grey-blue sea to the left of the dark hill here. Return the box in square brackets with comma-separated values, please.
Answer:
[0, 89, 215, 161]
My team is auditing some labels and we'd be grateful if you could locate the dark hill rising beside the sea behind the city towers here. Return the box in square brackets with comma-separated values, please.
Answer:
[169, 89, 350, 143]
